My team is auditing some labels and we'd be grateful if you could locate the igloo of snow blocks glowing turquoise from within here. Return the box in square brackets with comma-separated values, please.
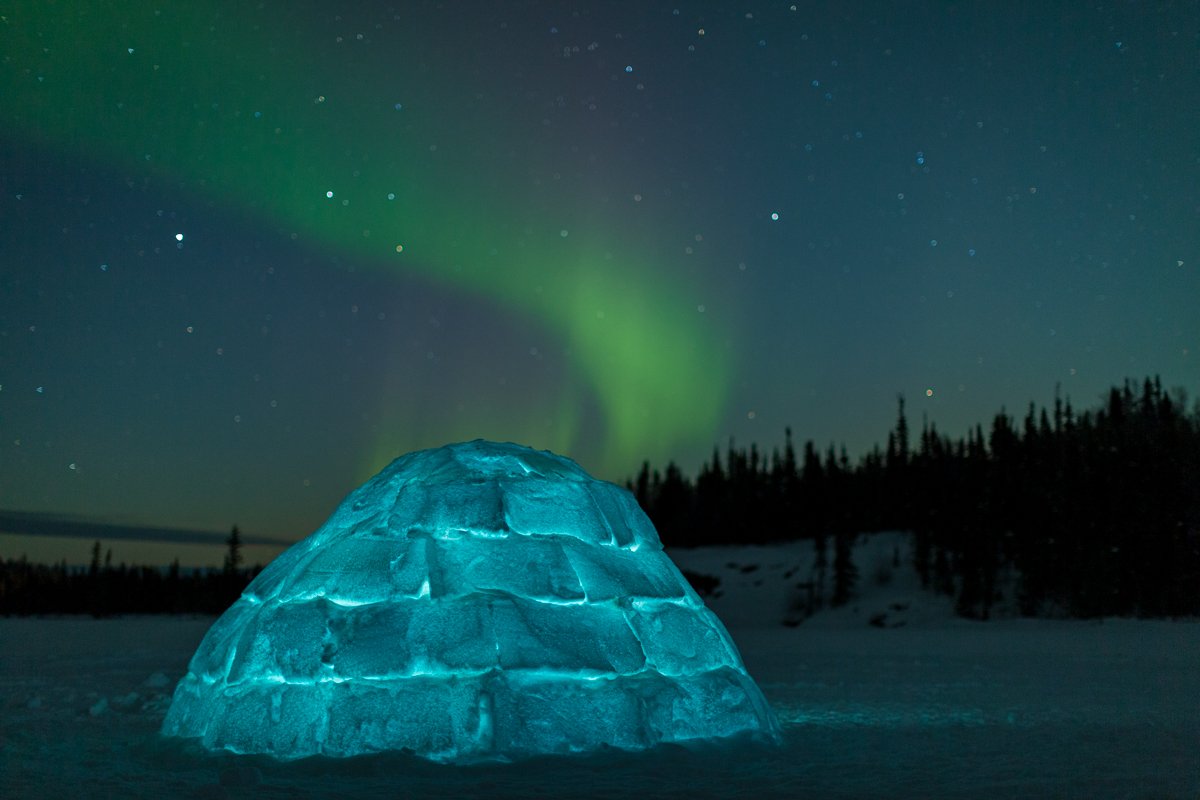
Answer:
[162, 440, 779, 762]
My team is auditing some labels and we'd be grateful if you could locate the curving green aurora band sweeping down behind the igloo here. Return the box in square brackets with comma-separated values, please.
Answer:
[0, 0, 730, 475]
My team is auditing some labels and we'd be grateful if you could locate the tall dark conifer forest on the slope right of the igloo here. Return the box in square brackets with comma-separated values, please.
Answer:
[628, 378, 1200, 619]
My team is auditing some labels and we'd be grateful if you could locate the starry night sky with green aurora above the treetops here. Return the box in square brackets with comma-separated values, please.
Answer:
[0, 0, 1200, 564]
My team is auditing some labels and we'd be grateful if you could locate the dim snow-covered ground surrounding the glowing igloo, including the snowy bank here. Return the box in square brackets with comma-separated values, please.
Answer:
[0, 535, 1200, 800]
